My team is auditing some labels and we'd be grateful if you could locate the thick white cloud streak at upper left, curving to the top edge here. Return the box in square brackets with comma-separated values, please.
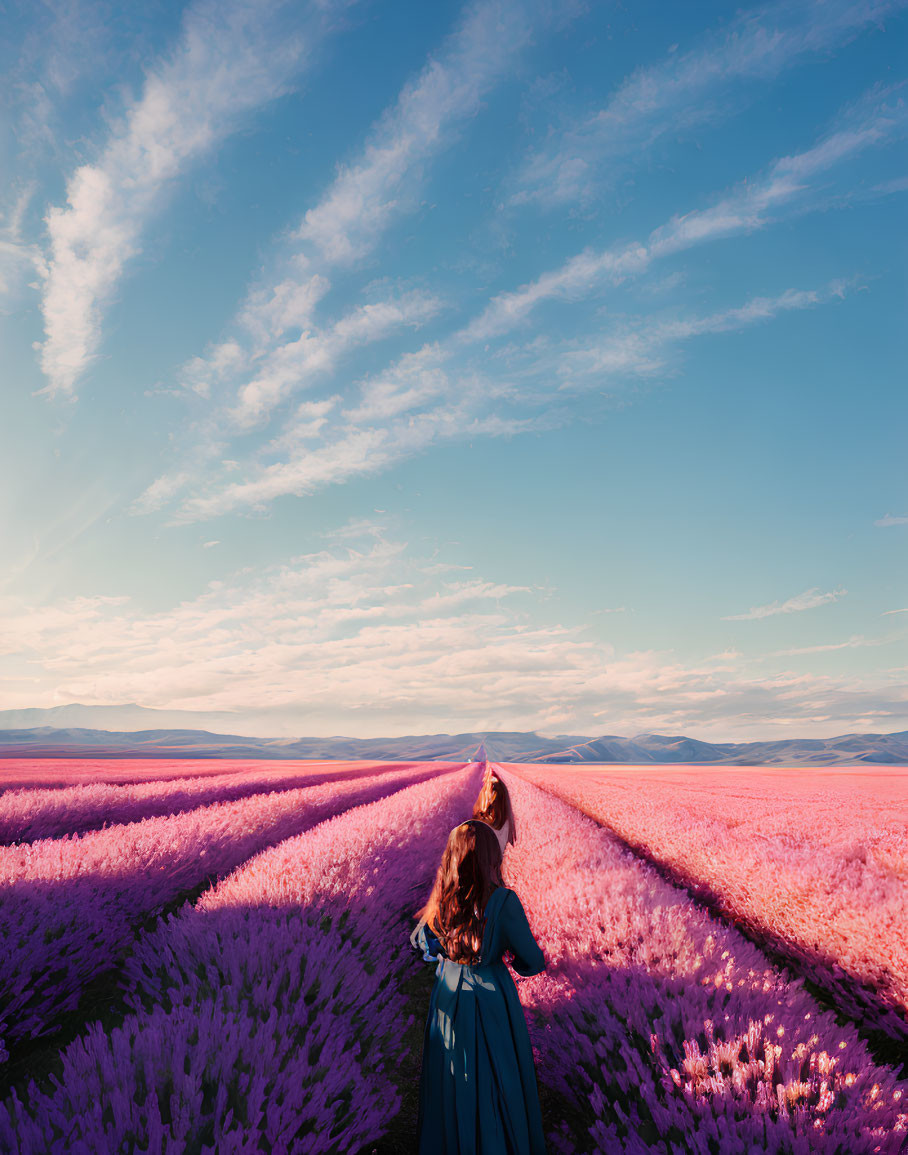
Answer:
[40, 0, 344, 395]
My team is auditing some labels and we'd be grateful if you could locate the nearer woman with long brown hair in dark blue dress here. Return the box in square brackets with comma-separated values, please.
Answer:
[418, 819, 545, 1155]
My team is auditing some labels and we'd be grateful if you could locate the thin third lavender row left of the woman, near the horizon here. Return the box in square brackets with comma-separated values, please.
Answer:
[0, 763, 438, 843]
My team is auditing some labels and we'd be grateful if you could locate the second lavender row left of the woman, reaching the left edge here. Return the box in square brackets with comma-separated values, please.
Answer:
[0, 766, 439, 1046]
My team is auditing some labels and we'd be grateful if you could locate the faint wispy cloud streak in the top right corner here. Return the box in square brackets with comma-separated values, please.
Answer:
[511, 0, 906, 207]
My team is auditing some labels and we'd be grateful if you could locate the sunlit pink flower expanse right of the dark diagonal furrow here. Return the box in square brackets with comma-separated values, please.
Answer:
[508, 767, 908, 1045]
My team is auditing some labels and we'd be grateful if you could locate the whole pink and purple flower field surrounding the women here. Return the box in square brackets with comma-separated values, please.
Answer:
[0, 759, 908, 1155]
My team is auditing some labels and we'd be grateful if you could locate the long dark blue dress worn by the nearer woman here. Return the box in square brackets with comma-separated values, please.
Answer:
[418, 886, 545, 1155]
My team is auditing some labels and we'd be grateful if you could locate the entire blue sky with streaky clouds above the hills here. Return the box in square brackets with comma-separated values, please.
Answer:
[0, 0, 908, 740]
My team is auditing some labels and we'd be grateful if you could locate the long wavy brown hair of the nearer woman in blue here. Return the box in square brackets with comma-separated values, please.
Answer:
[420, 819, 501, 964]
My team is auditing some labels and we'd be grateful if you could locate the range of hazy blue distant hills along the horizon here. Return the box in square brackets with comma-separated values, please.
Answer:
[0, 711, 908, 766]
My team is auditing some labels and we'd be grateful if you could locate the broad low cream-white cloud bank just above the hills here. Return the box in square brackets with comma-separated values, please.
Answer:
[0, 523, 908, 738]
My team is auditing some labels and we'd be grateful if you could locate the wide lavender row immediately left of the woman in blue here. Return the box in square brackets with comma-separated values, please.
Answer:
[0, 763, 481, 1155]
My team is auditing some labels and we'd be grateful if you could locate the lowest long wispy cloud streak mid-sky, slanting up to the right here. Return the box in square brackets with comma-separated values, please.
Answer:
[136, 282, 843, 524]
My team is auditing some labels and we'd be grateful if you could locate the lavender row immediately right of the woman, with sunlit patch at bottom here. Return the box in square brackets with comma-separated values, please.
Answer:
[499, 772, 908, 1155]
